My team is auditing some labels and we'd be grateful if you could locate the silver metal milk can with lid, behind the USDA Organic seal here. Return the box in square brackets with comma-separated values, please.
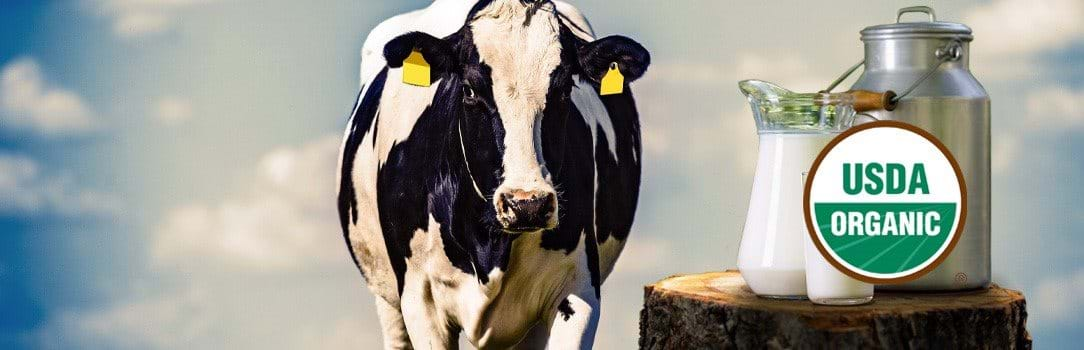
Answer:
[828, 7, 990, 290]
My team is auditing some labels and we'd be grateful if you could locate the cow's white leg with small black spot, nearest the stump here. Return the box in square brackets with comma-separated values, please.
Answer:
[546, 283, 602, 350]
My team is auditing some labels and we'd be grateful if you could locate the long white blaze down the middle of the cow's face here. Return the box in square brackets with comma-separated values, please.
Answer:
[470, 0, 562, 199]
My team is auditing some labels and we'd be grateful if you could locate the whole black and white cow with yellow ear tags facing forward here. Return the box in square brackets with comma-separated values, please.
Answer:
[338, 0, 650, 349]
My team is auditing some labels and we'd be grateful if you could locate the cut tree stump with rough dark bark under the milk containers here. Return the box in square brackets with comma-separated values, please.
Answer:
[640, 271, 1031, 349]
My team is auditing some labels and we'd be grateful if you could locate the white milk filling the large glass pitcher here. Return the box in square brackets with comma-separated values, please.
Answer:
[738, 132, 836, 299]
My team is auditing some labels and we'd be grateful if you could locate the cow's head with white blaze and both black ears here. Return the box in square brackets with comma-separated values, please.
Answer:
[384, 0, 650, 233]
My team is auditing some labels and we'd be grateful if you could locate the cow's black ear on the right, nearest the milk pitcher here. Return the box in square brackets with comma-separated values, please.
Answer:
[580, 36, 651, 82]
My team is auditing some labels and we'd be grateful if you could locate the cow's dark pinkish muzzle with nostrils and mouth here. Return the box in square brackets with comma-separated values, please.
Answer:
[496, 190, 557, 233]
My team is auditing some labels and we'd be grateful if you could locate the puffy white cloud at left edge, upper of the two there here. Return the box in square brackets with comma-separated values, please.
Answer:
[0, 59, 95, 135]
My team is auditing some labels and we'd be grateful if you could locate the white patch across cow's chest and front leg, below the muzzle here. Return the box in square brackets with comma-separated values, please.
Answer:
[398, 215, 597, 348]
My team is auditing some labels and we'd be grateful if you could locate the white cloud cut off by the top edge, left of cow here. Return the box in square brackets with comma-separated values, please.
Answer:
[93, 0, 214, 39]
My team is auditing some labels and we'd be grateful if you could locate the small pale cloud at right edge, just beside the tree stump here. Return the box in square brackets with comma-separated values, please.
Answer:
[1029, 270, 1084, 324]
